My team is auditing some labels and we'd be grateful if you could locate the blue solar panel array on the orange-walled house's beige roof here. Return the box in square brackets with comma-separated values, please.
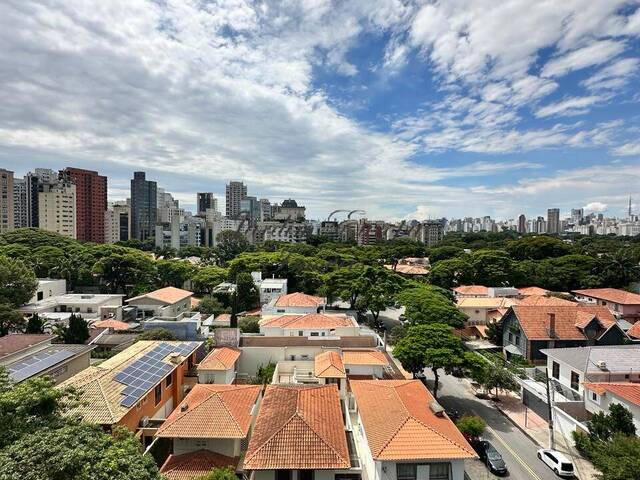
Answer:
[114, 342, 198, 408]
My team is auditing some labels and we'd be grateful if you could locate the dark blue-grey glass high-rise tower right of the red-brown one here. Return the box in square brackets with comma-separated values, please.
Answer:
[130, 172, 158, 240]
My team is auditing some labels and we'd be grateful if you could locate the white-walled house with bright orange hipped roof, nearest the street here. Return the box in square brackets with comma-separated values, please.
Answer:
[350, 380, 476, 480]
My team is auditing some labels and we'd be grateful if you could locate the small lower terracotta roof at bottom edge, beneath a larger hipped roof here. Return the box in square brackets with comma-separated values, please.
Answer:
[160, 450, 239, 480]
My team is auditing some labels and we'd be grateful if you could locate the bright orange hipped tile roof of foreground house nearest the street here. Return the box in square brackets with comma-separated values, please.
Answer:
[351, 380, 476, 461]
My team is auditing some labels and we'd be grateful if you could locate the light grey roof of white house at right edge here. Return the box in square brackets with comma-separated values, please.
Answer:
[540, 345, 640, 373]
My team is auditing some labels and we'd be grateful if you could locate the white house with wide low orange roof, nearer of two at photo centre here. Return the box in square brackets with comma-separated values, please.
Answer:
[260, 313, 360, 337]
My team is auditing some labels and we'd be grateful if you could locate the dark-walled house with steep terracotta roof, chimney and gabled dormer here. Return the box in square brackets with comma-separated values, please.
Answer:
[502, 305, 627, 363]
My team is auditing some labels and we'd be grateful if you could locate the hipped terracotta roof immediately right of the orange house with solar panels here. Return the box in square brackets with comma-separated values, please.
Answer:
[156, 384, 262, 438]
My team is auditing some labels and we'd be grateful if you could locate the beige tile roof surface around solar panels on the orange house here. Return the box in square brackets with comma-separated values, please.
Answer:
[58, 340, 202, 425]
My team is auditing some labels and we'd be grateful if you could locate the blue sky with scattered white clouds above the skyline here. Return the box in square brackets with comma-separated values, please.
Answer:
[0, 0, 640, 220]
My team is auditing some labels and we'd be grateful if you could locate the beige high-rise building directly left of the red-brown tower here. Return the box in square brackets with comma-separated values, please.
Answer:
[38, 181, 76, 238]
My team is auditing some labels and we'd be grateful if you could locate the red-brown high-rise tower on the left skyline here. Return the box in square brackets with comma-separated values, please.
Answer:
[60, 167, 107, 243]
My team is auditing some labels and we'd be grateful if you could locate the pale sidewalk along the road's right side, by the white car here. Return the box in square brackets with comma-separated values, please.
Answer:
[493, 392, 597, 480]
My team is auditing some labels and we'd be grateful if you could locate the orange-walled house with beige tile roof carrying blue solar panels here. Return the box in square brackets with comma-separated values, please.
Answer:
[61, 341, 202, 434]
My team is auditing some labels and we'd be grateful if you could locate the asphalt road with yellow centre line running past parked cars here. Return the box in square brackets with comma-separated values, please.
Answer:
[425, 371, 559, 480]
